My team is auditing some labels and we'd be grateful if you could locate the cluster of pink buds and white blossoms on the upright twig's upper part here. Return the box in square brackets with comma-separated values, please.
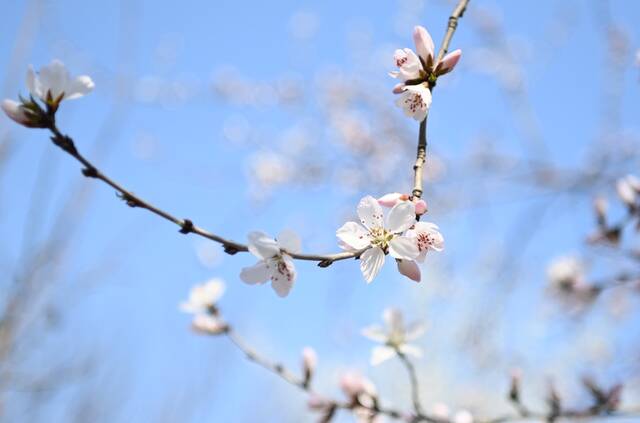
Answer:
[389, 26, 462, 122]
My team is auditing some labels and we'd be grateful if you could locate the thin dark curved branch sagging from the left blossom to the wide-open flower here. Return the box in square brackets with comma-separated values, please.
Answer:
[43, 121, 366, 267]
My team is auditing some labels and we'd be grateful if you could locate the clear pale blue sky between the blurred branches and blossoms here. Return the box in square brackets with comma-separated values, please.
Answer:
[0, 0, 640, 422]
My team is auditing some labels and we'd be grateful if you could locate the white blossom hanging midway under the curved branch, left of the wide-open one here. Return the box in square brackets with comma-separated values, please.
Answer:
[240, 231, 300, 297]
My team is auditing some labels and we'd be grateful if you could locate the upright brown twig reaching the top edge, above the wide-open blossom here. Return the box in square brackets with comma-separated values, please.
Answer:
[411, 0, 470, 199]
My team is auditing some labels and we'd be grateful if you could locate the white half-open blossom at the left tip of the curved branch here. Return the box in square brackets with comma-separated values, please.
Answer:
[27, 59, 95, 107]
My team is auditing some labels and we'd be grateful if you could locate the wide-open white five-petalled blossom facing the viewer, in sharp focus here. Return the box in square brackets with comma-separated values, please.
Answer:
[336, 196, 420, 282]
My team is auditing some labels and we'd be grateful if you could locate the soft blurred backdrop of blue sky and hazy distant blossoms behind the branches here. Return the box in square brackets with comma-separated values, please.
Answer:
[0, 0, 640, 422]
